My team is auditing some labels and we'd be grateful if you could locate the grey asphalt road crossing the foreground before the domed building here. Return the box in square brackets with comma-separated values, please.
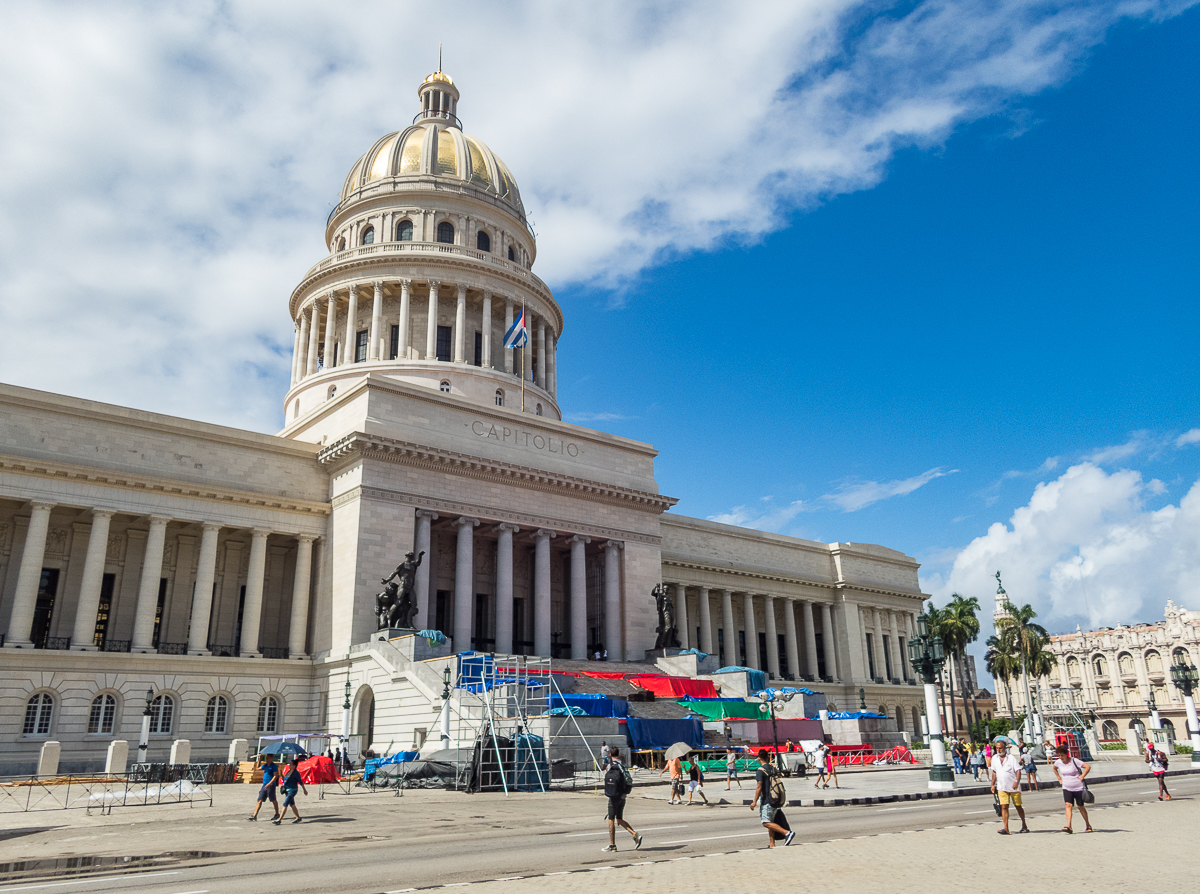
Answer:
[0, 775, 1200, 894]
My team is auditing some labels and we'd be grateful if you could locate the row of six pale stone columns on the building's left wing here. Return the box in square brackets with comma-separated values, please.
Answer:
[4, 500, 317, 658]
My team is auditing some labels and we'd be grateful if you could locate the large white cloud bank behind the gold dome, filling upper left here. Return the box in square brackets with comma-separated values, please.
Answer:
[0, 0, 1188, 430]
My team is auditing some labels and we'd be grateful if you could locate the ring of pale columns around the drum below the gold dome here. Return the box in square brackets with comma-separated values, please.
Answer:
[292, 280, 558, 396]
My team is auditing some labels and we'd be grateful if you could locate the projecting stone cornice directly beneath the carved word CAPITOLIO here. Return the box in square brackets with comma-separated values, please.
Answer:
[317, 432, 678, 512]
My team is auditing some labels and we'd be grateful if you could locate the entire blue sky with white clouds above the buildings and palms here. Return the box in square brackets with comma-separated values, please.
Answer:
[0, 0, 1200, 676]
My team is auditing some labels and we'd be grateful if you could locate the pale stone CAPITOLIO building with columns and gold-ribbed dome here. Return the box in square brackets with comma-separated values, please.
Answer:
[0, 71, 925, 774]
